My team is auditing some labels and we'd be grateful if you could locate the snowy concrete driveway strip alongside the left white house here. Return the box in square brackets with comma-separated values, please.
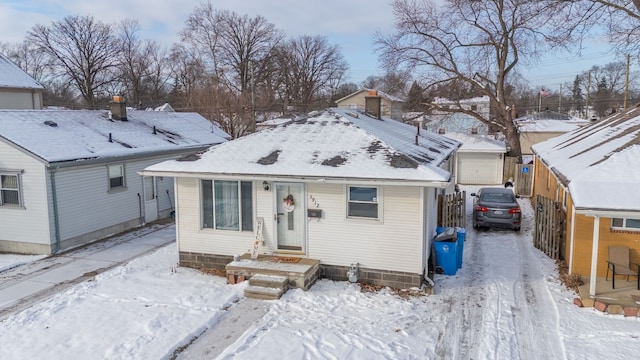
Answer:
[0, 223, 176, 321]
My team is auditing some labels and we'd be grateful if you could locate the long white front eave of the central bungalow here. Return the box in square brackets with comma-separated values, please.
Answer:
[138, 170, 452, 188]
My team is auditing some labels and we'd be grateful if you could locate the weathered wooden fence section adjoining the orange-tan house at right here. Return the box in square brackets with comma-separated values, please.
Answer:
[533, 195, 566, 260]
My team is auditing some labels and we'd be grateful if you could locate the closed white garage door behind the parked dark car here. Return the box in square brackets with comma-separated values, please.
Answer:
[457, 153, 502, 185]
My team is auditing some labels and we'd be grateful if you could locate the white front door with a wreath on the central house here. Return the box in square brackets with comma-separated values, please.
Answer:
[275, 183, 306, 251]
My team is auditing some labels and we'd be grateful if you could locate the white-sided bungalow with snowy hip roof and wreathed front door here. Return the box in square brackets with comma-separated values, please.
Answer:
[141, 109, 460, 287]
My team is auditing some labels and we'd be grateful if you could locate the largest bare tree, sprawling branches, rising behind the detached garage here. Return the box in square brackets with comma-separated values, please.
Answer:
[376, 0, 569, 158]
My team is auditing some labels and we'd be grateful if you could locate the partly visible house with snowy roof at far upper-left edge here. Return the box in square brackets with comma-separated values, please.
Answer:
[0, 54, 44, 109]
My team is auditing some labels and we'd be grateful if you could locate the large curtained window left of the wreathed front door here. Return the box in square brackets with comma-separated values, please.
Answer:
[200, 180, 253, 231]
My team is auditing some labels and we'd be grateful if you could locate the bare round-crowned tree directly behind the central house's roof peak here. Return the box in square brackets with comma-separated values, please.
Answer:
[276, 35, 348, 112]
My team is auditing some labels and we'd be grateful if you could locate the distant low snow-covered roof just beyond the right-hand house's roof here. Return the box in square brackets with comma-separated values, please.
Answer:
[513, 111, 591, 133]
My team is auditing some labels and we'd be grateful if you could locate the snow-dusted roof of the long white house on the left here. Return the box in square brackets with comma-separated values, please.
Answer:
[0, 110, 229, 163]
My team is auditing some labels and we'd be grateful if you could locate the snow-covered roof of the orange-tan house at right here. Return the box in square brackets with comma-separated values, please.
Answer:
[532, 108, 640, 211]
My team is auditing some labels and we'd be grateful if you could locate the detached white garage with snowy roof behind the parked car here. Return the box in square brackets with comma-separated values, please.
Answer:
[445, 133, 507, 185]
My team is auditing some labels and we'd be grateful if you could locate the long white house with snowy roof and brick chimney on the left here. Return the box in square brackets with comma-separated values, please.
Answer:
[0, 98, 228, 254]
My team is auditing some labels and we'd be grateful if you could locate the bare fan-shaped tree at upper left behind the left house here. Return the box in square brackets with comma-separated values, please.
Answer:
[27, 16, 120, 108]
